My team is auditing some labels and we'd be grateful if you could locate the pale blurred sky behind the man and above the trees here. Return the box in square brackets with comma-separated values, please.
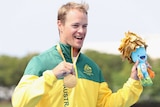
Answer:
[0, 0, 160, 58]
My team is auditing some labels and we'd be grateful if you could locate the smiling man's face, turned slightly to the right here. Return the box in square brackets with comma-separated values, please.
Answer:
[58, 9, 88, 49]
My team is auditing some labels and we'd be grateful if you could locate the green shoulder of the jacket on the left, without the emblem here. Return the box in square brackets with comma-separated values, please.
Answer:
[25, 46, 59, 76]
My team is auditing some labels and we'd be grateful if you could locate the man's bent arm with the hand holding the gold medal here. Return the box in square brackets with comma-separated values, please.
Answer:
[12, 57, 73, 107]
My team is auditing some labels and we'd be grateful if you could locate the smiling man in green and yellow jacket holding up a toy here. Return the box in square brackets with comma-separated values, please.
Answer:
[12, 2, 143, 107]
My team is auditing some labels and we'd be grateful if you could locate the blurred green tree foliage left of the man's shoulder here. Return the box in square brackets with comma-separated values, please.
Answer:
[0, 54, 35, 86]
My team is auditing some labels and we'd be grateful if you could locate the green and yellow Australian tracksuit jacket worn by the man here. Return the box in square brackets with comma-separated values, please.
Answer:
[12, 43, 143, 107]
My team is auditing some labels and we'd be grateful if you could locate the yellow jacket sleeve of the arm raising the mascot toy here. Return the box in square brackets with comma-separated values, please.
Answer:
[97, 78, 143, 107]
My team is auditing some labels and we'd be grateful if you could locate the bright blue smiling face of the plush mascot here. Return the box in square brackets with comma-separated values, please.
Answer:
[131, 47, 147, 63]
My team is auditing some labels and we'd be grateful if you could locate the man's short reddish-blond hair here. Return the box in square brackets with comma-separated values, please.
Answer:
[57, 2, 89, 24]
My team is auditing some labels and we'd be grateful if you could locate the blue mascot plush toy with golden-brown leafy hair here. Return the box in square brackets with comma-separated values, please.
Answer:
[118, 32, 155, 86]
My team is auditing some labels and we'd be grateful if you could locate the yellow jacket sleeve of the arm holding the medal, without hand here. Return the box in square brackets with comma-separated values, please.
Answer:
[12, 70, 57, 107]
